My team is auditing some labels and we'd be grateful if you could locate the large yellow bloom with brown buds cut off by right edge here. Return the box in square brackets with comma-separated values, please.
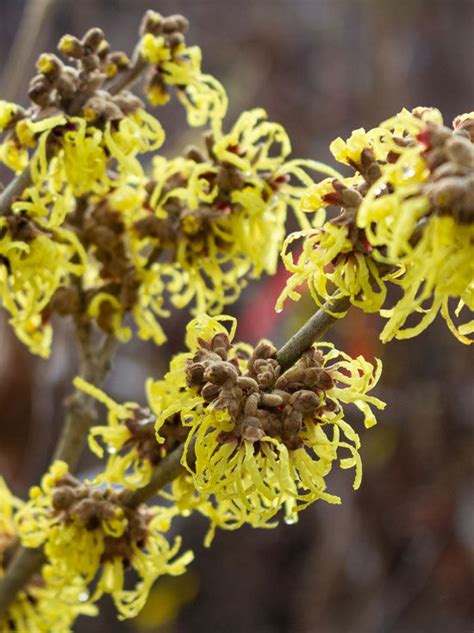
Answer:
[357, 109, 474, 343]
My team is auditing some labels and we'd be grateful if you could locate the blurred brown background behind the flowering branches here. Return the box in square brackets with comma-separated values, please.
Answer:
[0, 0, 474, 633]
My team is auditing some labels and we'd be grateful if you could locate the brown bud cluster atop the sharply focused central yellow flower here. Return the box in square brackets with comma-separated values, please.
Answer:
[187, 334, 339, 450]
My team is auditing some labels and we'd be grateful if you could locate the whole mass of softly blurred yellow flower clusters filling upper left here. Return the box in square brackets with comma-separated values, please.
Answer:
[0, 11, 337, 356]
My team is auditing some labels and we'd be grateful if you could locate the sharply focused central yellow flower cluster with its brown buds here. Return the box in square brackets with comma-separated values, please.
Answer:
[148, 317, 384, 528]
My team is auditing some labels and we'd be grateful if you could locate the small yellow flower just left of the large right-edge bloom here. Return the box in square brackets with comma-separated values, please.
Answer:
[276, 169, 394, 317]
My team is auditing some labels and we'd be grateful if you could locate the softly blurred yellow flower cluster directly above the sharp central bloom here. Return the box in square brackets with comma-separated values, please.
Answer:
[126, 109, 338, 313]
